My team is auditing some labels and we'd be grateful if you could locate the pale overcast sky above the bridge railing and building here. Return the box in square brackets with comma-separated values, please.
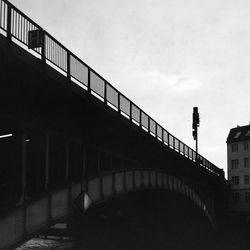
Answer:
[10, 0, 250, 177]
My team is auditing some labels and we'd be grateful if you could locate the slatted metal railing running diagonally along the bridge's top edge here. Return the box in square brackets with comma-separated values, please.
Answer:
[0, 0, 223, 177]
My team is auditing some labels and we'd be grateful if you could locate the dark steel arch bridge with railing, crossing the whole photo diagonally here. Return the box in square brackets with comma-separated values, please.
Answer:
[0, 0, 226, 249]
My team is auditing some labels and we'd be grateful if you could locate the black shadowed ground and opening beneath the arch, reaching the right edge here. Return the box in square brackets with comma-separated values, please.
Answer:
[16, 191, 250, 250]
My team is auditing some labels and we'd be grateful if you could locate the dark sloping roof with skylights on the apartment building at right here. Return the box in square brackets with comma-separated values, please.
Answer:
[227, 125, 250, 143]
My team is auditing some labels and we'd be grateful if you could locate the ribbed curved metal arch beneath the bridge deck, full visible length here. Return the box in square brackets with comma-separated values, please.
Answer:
[0, 169, 214, 249]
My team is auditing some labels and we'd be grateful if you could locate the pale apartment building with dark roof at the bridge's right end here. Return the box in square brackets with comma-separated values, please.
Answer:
[227, 125, 250, 211]
